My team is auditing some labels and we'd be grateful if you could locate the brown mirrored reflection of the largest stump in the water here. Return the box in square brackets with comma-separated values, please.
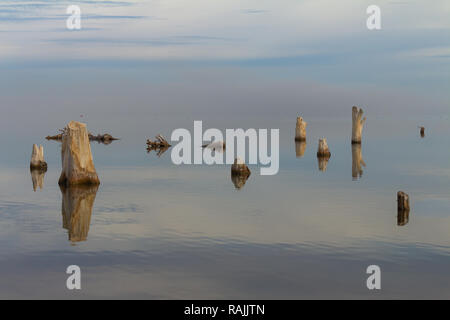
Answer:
[60, 186, 98, 242]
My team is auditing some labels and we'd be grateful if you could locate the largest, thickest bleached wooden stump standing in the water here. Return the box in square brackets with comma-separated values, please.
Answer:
[59, 121, 100, 186]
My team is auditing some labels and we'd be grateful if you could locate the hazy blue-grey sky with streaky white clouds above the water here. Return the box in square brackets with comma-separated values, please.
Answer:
[0, 0, 450, 136]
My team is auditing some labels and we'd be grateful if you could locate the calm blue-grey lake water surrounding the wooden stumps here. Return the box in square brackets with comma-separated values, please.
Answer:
[0, 113, 450, 299]
